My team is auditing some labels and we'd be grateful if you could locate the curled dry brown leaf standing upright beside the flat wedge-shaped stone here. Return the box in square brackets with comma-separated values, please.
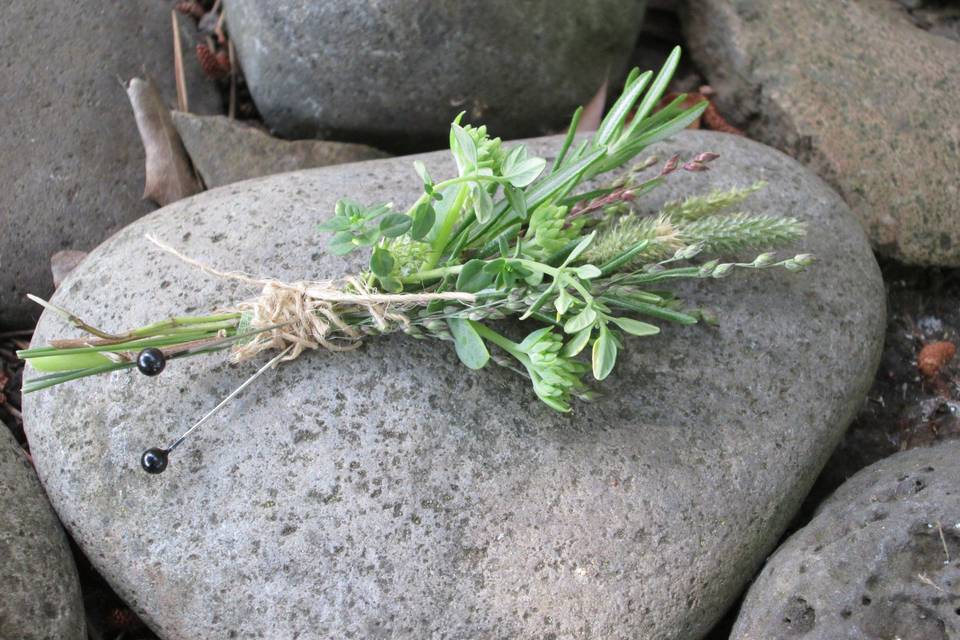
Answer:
[127, 78, 200, 206]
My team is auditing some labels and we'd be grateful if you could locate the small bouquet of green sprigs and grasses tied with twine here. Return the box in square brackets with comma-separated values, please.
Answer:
[19, 49, 812, 420]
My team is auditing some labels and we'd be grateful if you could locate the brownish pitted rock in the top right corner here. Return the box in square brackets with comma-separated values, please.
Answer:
[684, 0, 960, 266]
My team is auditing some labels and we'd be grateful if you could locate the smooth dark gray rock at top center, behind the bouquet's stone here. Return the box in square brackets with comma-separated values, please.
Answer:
[224, 0, 645, 148]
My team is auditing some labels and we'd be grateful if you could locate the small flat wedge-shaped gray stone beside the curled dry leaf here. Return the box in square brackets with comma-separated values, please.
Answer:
[173, 111, 389, 189]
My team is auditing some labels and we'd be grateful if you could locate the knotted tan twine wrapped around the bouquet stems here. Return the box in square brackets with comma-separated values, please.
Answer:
[145, 234, 476, 362]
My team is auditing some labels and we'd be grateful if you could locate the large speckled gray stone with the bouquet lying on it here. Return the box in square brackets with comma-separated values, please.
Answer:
[24, 132, 884, 640]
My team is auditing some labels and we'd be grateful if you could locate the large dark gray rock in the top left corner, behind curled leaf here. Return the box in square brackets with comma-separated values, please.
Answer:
[0, 0, 220, 327]
